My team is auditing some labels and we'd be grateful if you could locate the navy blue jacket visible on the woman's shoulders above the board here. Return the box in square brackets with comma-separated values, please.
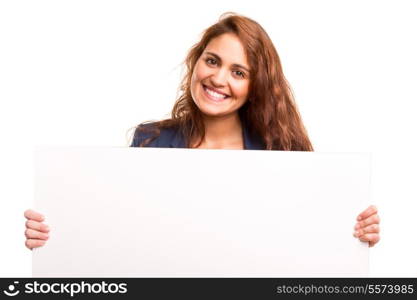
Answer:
[130, 123, 265, 150]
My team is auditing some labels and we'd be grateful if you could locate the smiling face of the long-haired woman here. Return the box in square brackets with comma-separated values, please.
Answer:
[191, 33, 250, 117]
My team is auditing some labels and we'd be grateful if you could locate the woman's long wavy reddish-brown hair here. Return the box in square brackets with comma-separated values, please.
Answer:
[133, 13, 313, 151]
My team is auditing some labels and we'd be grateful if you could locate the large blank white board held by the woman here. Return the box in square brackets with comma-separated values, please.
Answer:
[33, 148, 370, 277]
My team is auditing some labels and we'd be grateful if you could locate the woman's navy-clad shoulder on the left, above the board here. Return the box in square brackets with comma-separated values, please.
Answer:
[130, 122, 183, 148]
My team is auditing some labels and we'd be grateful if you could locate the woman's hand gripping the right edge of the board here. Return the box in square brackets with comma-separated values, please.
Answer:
[353, 205, 380, 247]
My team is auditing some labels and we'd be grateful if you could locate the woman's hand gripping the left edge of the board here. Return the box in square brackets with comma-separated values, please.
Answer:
[25, 209, 49, 250]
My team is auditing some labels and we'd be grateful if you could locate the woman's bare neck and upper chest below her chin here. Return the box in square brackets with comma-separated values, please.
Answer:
[198, 113, 244, 149]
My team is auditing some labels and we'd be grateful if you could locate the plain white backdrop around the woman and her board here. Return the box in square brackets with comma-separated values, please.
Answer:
[0, 0, 417, 277]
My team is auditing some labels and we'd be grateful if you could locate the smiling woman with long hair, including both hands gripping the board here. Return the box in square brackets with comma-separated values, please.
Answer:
[25, 14, 380, 249]
